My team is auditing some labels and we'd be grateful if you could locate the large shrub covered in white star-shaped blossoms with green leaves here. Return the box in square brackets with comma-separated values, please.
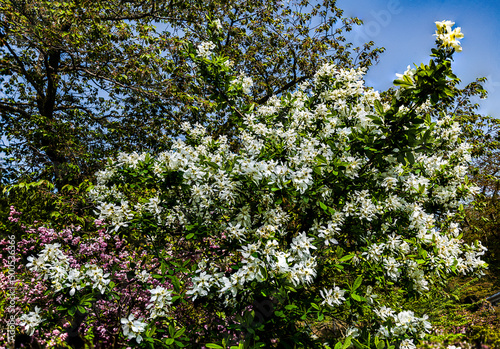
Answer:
[0, 20, 485, 349]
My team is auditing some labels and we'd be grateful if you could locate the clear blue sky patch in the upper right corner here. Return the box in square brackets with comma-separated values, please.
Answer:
[336, 0, 500, 118]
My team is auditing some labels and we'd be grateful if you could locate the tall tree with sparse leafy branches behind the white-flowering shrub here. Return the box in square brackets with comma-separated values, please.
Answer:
[0, 0, 381, 187]
